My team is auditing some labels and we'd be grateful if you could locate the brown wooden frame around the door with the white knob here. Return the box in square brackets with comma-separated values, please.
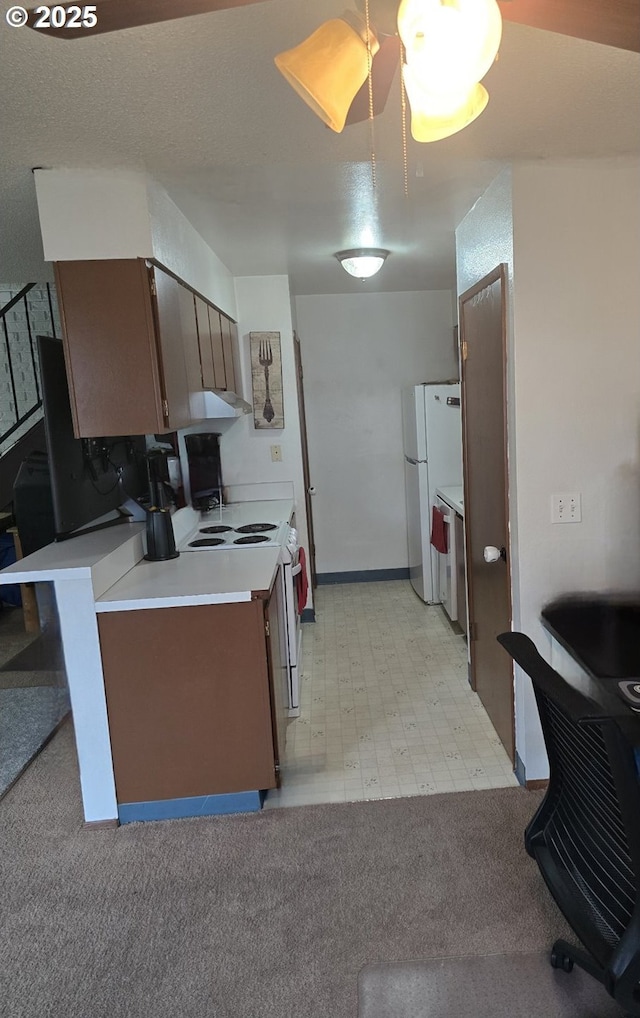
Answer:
[458, 262, 516, 753]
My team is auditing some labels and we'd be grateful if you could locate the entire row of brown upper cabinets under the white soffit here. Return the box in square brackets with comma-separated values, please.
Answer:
[55, 259, 237, 438]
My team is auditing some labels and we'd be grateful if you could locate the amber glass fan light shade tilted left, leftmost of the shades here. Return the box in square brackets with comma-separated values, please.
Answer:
[275, 17, 380, 133]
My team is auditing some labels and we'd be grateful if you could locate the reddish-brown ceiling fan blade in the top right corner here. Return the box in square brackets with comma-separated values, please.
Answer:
[499, 0, 640, 53]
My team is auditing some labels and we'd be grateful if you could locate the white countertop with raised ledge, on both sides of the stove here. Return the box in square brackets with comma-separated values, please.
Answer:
[0, 499, 294, 612]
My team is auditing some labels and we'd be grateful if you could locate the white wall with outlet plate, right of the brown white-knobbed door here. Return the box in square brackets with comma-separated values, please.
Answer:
[456, 159, 640, 779]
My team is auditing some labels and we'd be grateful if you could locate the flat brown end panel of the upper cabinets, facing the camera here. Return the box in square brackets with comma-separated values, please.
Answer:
[55, 259, 161, 438]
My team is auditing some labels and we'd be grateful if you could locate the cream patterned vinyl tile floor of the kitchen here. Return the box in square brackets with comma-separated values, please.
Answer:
[265, 580, 518, 808]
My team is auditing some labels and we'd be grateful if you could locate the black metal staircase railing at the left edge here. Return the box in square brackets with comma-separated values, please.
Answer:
[0, 283, 55, 454]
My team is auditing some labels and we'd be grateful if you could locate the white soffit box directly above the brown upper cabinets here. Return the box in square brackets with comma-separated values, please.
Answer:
[34, 169, 236, 319]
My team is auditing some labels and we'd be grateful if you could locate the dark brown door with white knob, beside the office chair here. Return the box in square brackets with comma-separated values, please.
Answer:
[460, 266, 515, 761]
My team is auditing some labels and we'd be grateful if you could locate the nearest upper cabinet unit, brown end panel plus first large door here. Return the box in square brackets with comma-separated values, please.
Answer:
[55, 259, 190, 438]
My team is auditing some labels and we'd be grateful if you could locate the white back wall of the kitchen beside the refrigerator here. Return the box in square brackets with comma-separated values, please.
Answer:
[295, 290, 457, 573]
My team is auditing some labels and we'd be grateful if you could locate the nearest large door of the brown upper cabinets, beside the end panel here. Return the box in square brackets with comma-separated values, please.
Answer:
[150, 267, 191, 431]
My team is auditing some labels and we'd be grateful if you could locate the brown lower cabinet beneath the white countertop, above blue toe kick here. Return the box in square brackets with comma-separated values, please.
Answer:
[98, 583, 284, 804]
